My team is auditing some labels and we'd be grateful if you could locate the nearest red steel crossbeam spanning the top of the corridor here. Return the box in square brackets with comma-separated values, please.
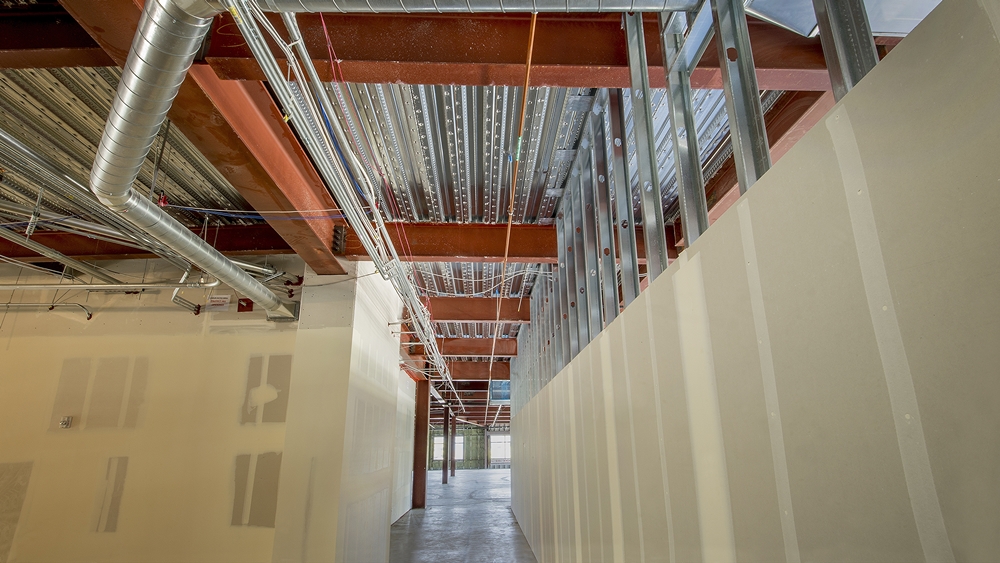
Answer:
[205, 14, 830, 90]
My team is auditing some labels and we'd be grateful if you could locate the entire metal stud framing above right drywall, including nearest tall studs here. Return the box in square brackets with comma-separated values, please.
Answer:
[511, 5, 770, 414]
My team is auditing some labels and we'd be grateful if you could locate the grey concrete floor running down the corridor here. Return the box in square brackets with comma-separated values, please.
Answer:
[389, 469, 535, 563]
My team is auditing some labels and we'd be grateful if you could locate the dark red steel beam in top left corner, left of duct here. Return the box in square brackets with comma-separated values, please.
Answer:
[0, 12, 115, 68]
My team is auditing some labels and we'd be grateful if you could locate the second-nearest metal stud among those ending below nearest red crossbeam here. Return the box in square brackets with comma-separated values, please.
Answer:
[591, 97, 618, 327]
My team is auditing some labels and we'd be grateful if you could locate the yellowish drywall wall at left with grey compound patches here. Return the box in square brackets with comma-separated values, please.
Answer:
[0, 259, 413, 562]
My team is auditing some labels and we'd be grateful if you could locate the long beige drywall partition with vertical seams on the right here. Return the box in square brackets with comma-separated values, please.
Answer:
[512, 0, 1000, 563]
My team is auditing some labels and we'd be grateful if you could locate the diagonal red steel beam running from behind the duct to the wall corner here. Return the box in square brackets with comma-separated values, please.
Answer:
[60, 0, 346, 274]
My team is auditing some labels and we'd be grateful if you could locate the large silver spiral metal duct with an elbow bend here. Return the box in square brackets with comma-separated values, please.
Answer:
[90, 0, 295, 320]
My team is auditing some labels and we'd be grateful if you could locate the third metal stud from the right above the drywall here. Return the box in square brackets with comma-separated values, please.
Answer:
[659, 12, 708, 246]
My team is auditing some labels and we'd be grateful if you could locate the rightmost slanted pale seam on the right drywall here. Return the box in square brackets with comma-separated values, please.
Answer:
[826, 108, 955, 562]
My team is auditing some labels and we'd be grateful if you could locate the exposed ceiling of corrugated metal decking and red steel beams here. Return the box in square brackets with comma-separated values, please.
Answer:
[0, 0, 920, 424]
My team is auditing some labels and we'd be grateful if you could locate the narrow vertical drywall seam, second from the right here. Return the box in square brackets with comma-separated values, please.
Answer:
[737, 199, 801, 563]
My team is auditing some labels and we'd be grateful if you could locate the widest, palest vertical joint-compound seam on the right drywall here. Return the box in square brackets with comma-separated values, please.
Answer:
[672, 251, 736, 563]
